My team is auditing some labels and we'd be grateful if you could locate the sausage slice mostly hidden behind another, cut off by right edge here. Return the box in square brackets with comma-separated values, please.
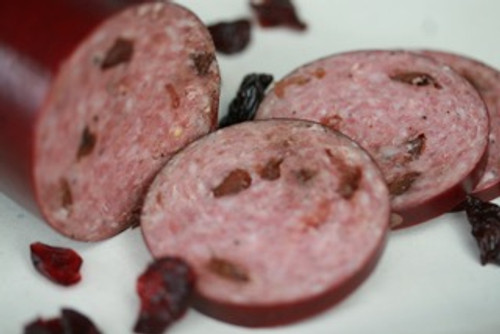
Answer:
[423, 50, 500, 201]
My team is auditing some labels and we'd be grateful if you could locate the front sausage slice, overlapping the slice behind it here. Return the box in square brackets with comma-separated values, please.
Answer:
[141, 120, 390, 327]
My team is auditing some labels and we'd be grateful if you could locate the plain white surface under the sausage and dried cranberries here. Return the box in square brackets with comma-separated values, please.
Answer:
[0, 0, 500, 334]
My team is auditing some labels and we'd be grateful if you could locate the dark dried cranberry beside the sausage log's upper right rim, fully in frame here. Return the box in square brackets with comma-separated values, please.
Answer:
[208, 19, 251, 55]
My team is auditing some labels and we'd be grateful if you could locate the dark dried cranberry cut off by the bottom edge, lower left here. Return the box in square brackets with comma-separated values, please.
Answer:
[24, 308, 101, 334]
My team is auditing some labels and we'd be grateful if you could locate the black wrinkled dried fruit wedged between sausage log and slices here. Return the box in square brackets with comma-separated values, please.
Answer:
[219, 73, 273, 128]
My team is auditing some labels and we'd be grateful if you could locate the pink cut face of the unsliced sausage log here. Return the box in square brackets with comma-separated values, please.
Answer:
[34, 2, 219, 241]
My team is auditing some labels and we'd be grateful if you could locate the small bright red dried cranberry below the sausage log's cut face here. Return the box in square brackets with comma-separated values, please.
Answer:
[30, 242, 83, 286]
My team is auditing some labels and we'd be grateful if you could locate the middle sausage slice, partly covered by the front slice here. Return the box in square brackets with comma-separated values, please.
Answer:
[256, 51, 489, 227]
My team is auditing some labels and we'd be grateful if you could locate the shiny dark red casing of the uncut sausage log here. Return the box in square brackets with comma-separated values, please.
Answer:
[0, 0, 135, 206]
